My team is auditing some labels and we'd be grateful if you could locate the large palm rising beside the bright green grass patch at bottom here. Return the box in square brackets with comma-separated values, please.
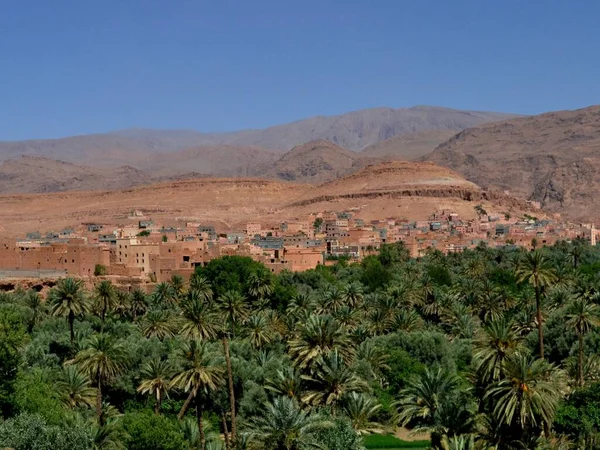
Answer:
[395, 368, 459, 448]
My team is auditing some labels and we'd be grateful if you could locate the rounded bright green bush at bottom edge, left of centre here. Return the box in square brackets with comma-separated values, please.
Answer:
[123, 411, 185, 450]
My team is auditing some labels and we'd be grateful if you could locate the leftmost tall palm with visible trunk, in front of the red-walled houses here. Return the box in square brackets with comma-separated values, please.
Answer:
[48, 278, 89, 345]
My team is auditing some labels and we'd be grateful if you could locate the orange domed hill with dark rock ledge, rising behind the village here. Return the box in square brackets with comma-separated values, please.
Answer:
[287, 161, 532, 219]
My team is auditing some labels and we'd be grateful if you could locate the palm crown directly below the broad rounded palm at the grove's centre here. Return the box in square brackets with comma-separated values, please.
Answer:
[302, 350, 369, 408]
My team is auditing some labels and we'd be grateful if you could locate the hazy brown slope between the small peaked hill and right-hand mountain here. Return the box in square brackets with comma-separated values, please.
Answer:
[360, 130, 456, 161]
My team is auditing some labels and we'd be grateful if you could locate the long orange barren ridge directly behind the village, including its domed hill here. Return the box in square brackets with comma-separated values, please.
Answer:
[0, 162, 540, 236]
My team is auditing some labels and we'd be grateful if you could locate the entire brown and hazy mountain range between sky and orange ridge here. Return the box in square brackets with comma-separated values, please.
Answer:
[0, 106, 600, 220]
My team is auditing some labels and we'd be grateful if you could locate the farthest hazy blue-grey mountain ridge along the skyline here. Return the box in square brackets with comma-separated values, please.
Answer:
[0, 106, 509, 169]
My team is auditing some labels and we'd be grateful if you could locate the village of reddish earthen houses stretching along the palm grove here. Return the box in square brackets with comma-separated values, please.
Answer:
[0, 208, 597, 282]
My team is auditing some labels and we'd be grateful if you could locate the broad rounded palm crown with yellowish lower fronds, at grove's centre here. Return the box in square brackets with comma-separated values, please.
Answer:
[288, 315, 350, 369]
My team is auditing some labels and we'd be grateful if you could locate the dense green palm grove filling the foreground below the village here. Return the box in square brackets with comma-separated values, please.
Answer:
[0, 241, 600, 450]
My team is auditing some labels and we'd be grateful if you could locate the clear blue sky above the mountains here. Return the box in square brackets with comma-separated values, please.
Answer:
[0, 0, 600, 140]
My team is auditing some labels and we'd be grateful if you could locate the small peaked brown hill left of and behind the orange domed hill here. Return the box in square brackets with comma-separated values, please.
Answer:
[263, 140, 368, 183]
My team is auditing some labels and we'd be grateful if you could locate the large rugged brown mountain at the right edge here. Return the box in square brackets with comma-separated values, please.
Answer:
[428, 106, 600, 219]
